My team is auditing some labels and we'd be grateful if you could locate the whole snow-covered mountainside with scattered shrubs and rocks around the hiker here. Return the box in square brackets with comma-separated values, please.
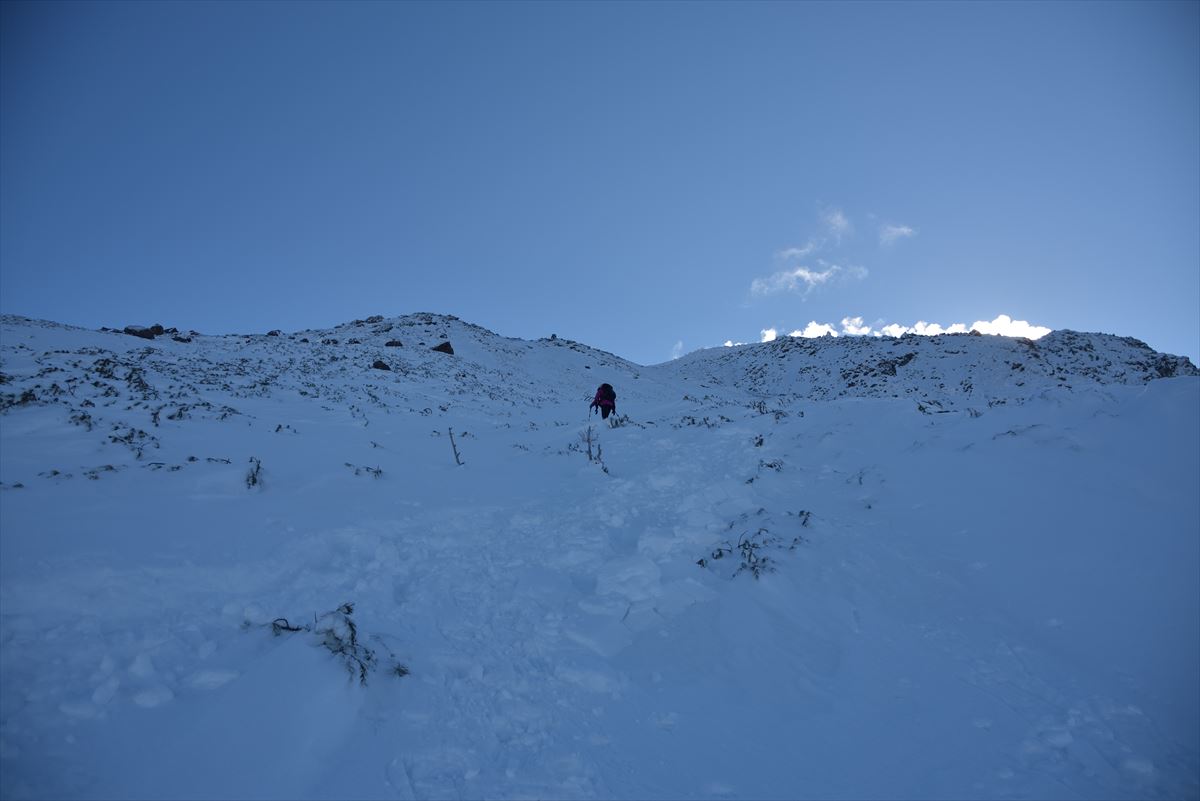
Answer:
[0, 315, 1200, 799]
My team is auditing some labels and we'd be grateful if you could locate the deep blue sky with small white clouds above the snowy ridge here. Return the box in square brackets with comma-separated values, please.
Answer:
[0, 0, 1200, 363]
